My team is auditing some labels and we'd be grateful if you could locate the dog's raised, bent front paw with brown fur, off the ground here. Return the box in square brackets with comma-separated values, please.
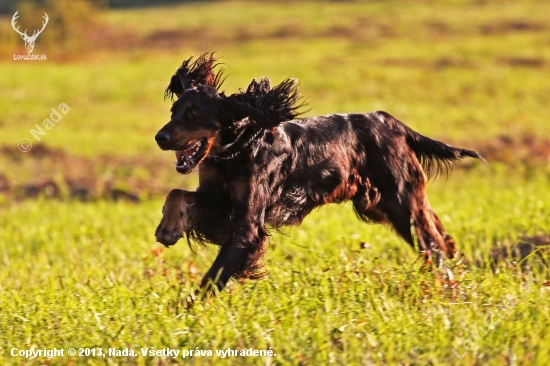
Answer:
[155, 189, 193, 246]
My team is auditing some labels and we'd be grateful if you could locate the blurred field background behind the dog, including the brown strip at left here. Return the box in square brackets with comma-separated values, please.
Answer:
[0, 0, 550, 202]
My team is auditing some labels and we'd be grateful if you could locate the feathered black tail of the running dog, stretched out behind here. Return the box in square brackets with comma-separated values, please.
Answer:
[374, 112, 485, 179]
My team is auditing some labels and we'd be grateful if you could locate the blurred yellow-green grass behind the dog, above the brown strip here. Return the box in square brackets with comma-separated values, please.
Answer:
[0, 1, 550, 155]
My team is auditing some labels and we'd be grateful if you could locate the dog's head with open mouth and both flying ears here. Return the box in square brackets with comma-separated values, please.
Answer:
[155, 54, 300, 174]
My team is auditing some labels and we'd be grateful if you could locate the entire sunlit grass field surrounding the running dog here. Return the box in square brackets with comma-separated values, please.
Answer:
[0, 1, 550, 365]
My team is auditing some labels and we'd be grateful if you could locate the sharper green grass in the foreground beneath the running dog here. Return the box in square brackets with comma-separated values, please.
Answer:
[0, 172, 550, 365]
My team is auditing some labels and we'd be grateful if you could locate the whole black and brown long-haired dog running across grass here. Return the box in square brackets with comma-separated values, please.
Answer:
[155, 53, 481, 289]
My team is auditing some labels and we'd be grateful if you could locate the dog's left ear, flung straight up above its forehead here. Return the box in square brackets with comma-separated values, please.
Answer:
[164, 52, 225, 100]
